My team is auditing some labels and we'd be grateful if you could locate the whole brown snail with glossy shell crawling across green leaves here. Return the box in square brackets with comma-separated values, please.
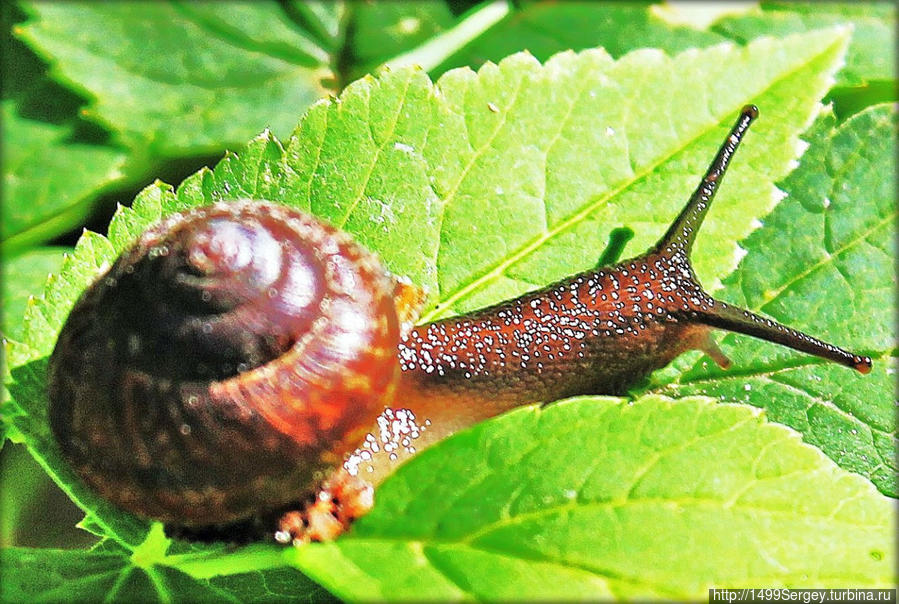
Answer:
[48, 105, 871, 543]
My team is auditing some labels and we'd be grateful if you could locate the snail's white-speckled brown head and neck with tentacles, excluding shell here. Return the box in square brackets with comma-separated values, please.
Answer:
[386, 106, 871, 452]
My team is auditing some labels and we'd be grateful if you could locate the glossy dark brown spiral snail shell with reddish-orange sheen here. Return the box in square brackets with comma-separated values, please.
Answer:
[49, 201, 399, 527]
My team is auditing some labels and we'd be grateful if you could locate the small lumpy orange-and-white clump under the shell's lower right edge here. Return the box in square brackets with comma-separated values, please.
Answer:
[275, 468, 374, 546]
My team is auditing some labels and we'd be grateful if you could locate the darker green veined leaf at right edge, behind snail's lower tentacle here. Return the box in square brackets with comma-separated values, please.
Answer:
[662, 105, 899, 496]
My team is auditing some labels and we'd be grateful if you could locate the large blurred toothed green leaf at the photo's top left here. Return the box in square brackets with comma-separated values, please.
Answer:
[17, 2, 336, 156]
